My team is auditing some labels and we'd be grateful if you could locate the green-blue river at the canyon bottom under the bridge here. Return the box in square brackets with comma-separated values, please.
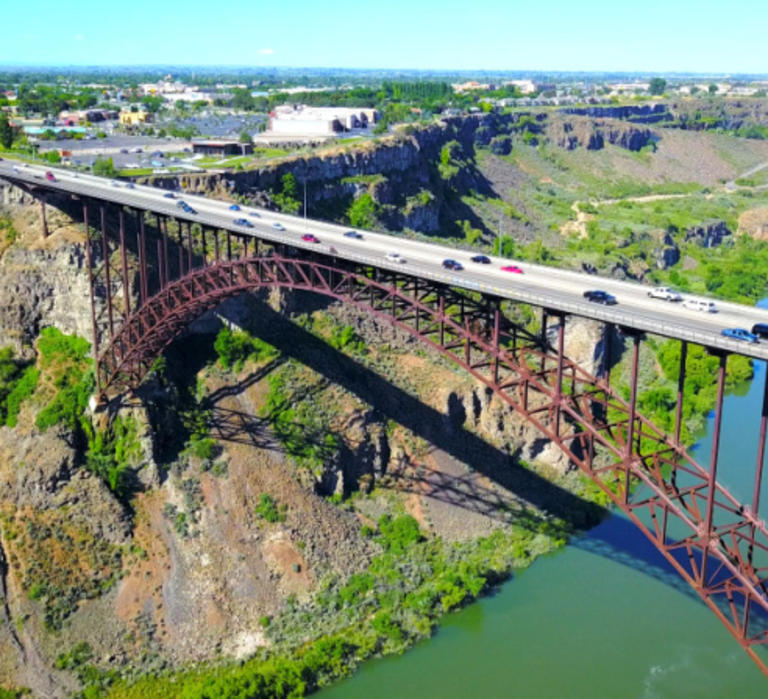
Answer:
[322, 320, 768, 699]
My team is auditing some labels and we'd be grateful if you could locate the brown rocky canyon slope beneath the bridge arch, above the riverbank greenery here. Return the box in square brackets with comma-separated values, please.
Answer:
[0, 186, 602, 697]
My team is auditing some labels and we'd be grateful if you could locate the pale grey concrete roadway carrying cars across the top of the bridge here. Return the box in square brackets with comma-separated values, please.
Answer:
[0, 160, 768, 360]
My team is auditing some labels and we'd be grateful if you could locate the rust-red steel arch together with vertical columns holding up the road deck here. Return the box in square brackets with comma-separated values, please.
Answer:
[66, 200, 768, 674]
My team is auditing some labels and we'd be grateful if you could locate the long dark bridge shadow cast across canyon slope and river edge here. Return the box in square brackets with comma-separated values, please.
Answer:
[152, 292, 768, 631]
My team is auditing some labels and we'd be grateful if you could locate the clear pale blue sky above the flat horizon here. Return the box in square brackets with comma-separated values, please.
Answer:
[6, 0, 768, 73]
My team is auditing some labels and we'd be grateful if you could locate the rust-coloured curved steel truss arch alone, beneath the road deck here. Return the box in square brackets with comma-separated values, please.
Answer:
[98, 255, 768, 674]
